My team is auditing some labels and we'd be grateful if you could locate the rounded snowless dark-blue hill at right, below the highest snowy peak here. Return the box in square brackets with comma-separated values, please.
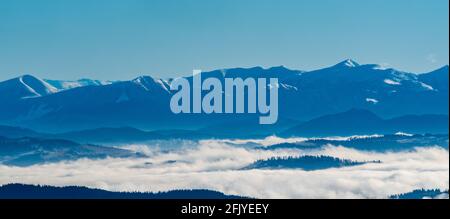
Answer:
[281, 109, 449, 137]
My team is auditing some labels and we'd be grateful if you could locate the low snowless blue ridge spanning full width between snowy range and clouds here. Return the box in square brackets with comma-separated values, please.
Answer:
[0, 109, 449, 144]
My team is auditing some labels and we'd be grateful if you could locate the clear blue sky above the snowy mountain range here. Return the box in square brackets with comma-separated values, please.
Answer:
[0, 0, 449, 80]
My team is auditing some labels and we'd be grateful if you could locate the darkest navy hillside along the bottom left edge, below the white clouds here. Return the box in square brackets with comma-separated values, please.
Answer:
[0, 184, 244, 199]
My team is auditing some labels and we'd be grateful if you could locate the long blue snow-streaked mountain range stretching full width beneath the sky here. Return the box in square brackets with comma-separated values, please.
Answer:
[0, 60, 449, 135]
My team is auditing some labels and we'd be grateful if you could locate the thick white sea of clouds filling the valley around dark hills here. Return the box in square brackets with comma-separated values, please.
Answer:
[0, 137, 449, 198]
